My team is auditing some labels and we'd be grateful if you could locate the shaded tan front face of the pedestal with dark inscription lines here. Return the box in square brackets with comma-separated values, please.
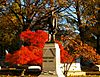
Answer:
[43, 48, 56, 71]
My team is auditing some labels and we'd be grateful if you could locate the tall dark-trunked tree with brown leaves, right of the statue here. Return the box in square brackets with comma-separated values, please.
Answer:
[59, 0, 99, 51]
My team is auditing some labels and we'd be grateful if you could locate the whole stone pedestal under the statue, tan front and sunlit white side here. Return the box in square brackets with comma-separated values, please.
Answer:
[39, 43, 64, 77]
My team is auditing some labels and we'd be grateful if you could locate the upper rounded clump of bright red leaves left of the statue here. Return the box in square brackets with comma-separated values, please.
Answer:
[20, 30, 48, 48]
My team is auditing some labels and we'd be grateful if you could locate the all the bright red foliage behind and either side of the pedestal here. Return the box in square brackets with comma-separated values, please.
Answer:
[5, 30, 73, 65]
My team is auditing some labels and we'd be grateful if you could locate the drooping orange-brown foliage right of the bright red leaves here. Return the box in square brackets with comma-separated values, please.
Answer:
[63, 37, 100, 64]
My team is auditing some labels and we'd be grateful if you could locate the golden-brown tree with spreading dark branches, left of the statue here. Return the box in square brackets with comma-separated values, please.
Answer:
[0, 0, 73, 51]
